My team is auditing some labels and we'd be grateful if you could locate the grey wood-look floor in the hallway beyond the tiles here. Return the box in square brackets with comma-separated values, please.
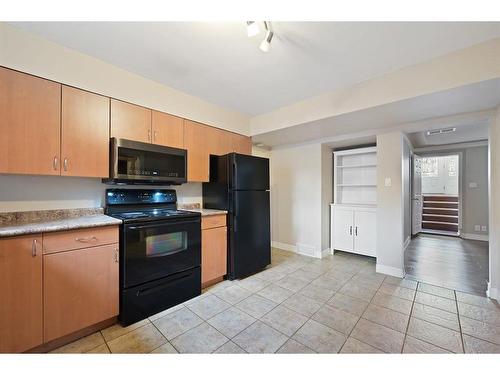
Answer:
[405, 233, 489, 295]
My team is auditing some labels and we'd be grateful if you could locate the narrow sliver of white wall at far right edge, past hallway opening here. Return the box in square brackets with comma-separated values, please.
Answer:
[488, 107, 500, 300]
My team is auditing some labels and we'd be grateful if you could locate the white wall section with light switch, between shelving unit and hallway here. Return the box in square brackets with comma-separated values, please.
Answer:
[377, 132, 404, 277]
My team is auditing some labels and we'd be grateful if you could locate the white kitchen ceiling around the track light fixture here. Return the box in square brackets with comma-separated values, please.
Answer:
[8, 22, 500, 115]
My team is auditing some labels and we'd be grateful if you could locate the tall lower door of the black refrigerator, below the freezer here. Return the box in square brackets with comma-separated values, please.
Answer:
[228, 191, 271, 280]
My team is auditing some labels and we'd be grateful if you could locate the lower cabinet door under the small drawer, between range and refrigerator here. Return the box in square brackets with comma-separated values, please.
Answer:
[201, 227, 227, 284]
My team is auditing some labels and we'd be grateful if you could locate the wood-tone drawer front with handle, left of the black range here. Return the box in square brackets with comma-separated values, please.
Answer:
[43, 226, 119, 254]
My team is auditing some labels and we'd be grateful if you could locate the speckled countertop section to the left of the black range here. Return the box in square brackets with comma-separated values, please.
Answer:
[0, 208, 122, 237]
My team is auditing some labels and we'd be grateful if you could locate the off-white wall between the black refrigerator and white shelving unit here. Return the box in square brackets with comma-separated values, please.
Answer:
[271, 143, 332, 257]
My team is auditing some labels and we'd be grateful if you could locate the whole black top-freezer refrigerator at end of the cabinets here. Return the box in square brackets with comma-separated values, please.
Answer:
[203, 153, 271, 280]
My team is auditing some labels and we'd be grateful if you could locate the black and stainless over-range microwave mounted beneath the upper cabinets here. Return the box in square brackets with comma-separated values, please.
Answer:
[103, 138, 187, 185]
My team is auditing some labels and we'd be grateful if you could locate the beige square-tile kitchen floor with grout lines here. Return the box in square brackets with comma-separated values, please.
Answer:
[49, 249, 500, 353]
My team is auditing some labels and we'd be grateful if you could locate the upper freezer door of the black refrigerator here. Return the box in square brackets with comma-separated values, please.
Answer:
[229, 153, 269, 190]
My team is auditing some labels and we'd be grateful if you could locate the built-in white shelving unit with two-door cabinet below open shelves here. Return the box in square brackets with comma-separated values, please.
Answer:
[331, 147, 377, 256]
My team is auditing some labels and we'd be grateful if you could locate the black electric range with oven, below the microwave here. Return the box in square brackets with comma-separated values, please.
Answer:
[105, 189, 201, 325]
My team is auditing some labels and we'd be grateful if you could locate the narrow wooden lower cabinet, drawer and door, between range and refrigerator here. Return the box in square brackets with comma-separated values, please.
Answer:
[201, 215, 227, 286]
